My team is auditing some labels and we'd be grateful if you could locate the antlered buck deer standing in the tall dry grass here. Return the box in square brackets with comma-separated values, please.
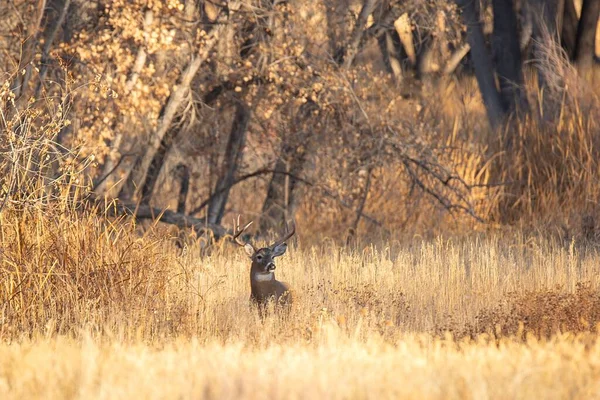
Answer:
[232, 220, 296, 318]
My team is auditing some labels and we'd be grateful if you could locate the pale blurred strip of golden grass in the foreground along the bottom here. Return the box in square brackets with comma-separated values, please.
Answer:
[0, 330, 600, 400]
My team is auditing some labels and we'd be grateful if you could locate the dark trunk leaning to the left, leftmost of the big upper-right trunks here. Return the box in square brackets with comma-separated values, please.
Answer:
[456, 0, 506, 129]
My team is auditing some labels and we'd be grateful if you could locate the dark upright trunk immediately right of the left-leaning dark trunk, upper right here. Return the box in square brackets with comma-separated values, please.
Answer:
[492, 0, 527, 112]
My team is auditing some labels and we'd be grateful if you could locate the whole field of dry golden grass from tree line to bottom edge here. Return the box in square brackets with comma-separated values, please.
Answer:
[0, 202, 600, 399]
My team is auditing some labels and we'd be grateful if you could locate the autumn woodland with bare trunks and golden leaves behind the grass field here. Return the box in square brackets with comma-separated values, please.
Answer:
[0, 0, 600, 240]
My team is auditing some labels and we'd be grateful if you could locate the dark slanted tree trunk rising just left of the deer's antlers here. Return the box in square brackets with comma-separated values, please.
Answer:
[207, 103, 251, 225]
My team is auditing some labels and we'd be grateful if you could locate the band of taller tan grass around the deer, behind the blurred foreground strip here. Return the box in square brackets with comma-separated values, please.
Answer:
[0, 206, 600, 344]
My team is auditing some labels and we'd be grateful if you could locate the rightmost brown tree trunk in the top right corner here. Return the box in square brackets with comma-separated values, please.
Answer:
[575, 0, 600, 80]
